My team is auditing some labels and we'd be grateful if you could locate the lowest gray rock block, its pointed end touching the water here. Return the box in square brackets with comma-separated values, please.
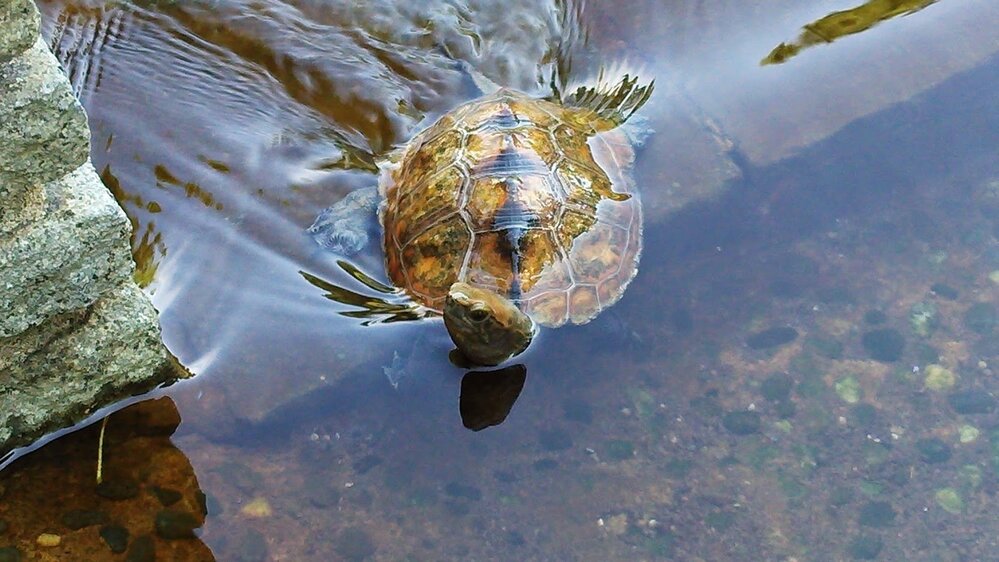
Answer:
[0, 284, 177, 456]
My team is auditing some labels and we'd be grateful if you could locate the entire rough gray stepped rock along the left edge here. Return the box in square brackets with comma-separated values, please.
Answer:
[0, 0, 179, 457]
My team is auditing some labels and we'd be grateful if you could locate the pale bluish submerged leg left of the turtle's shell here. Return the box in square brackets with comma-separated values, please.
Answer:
[308, 186, 380, 256]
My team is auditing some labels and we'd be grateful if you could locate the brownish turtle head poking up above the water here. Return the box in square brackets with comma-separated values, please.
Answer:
[444, 282, 536, 365]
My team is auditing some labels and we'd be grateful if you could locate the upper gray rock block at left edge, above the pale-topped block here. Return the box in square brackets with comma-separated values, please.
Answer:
[0, 38, 90, 200]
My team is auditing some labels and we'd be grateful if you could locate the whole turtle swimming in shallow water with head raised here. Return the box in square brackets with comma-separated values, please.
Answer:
[308, 74, 654, 365]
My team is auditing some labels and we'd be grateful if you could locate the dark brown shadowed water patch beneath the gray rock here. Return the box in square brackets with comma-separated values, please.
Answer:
[0, 398, 215, 562]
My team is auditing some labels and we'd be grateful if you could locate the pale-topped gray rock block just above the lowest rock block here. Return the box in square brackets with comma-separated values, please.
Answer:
[0, 163, 134, 336]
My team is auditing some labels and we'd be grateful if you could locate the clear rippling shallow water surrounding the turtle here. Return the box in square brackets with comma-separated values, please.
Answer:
[0, 0, 999, 561]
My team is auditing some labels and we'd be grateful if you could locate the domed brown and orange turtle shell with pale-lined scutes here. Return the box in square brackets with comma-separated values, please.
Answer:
[380, 89, 642, 327]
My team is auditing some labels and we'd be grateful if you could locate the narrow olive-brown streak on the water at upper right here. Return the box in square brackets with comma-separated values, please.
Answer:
[760, 0, 938, 65]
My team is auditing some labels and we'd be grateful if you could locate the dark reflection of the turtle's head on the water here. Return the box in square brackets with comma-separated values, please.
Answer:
[459, 365, 527, 431]
